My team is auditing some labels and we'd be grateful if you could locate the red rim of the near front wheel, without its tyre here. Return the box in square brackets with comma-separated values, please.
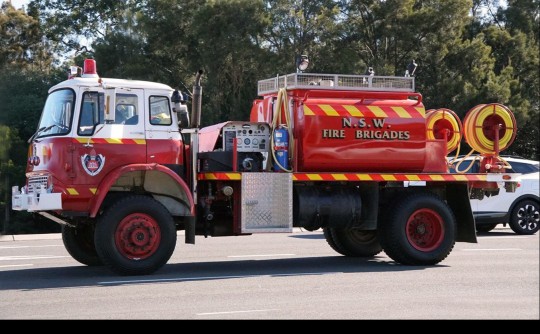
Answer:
[114, 213, 161, 260]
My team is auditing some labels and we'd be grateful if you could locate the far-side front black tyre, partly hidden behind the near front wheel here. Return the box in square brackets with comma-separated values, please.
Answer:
[62, 225, 103, 266]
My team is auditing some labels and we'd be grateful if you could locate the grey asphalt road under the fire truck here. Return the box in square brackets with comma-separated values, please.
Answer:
[0, 229, 540, 320]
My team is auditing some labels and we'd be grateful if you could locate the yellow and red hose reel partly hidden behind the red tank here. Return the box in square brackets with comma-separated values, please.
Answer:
[426, 108, 462, 154]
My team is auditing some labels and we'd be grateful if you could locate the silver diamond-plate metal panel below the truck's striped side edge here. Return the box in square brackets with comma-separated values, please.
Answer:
[241, 173, 293, 233]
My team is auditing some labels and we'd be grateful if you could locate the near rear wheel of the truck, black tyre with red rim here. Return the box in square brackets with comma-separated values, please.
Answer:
[379, 193, 456, 265]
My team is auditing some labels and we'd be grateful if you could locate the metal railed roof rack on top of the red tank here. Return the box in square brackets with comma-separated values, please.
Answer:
[257, 73, 414, 96]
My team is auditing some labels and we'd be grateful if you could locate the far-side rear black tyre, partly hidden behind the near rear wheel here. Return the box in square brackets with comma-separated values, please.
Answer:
[324, 228, 382, 257]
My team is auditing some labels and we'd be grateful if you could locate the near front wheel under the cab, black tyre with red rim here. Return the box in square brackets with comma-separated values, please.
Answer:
[95, 195, 176, 275]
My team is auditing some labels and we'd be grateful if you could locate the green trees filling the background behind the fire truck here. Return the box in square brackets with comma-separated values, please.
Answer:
[0, 0, 540, 231]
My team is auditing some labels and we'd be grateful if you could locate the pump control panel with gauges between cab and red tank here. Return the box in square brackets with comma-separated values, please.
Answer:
[223, 122, 270, 152]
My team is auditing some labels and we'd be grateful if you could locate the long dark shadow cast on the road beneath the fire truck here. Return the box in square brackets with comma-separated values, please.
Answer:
[0, 256, 445, 290]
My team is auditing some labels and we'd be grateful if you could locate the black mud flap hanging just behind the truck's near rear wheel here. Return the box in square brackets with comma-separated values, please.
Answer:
[446, 183, 478, 243]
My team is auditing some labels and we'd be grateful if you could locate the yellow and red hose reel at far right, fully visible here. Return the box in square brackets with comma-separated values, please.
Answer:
[463, 103, 517, 156]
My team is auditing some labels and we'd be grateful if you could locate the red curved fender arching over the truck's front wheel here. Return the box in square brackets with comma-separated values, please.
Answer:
[90, 163, 195, 218]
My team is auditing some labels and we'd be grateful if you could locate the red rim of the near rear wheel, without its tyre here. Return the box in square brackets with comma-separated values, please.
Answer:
[405, 209, 444, 252]
